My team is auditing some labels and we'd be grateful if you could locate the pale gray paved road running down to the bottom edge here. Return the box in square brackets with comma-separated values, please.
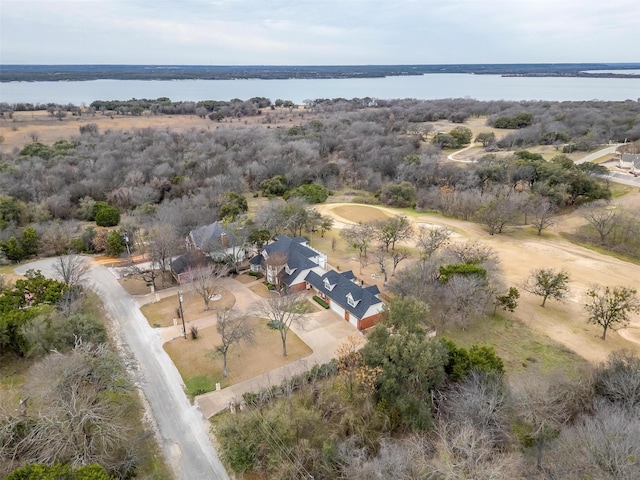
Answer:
[16, 259, 229, 480]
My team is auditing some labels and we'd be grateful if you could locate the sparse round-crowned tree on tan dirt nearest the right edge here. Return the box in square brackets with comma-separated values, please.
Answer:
[584, 285, 640, 340]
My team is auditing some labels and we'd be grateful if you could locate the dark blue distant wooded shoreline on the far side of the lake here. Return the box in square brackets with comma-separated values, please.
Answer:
[0, 63, 640, 82]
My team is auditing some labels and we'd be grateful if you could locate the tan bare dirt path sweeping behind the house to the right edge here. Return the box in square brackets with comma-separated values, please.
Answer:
[317, 200, 640, 362]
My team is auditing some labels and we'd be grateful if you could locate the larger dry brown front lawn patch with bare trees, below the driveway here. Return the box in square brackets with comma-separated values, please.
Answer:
[164, 318, 312, 393]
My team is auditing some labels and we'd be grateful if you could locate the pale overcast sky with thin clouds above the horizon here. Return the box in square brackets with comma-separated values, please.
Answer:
[0, 0, 640, 65]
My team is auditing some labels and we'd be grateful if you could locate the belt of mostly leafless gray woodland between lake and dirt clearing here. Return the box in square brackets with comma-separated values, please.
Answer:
[0, 98, 640, 256]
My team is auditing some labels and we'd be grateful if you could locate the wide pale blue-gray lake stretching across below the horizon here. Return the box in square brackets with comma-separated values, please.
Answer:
[0, 74, 640, 105]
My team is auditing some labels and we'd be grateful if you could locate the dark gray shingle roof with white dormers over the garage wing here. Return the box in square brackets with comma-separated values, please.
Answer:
[306, 270, 382, 319]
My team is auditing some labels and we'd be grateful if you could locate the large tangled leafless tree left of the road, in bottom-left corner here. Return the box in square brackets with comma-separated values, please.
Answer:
[0, 343, 135, 477]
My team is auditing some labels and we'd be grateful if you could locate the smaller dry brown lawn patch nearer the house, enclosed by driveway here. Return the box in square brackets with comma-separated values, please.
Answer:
[140, 288, 236, 327]
